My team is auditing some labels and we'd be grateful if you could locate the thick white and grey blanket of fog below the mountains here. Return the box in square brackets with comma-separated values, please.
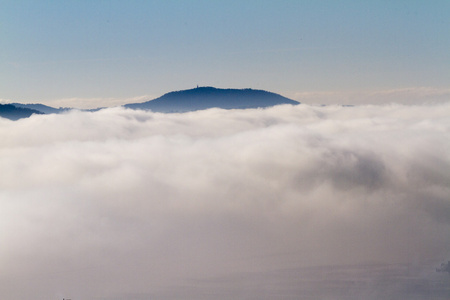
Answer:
[0, 104, 450, 300]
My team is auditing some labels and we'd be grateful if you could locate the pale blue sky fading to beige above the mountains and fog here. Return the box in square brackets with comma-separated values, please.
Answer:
[0, 0, 450, 107]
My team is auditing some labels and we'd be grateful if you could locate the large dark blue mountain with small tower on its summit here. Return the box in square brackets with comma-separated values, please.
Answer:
[124, 87, 299, 113]
